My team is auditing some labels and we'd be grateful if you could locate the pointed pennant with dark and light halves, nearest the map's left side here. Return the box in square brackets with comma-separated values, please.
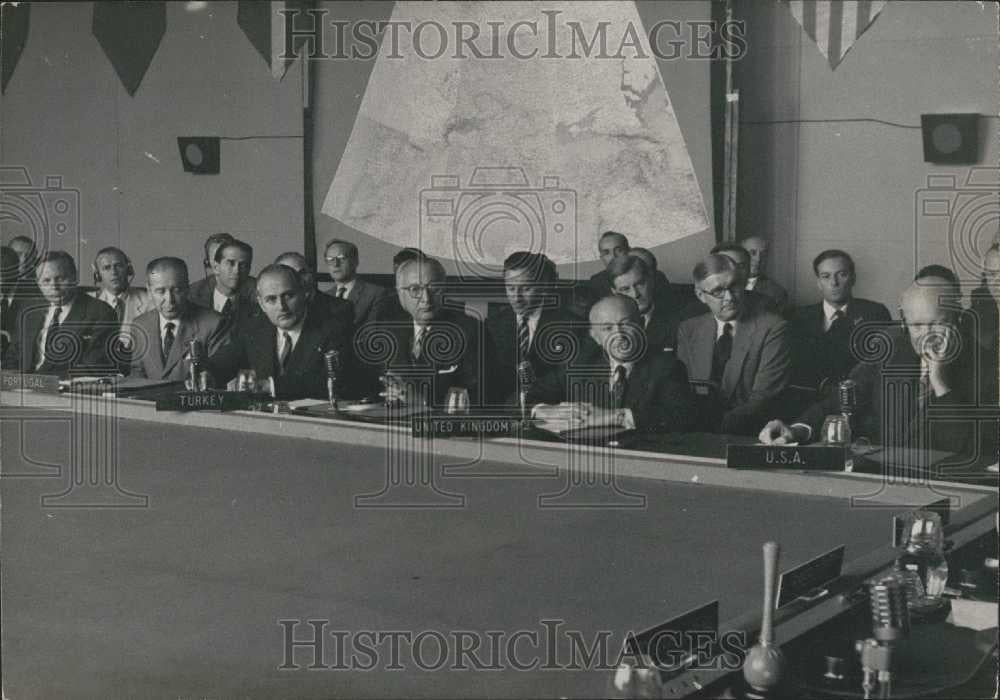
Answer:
[236, 0, 310, 80]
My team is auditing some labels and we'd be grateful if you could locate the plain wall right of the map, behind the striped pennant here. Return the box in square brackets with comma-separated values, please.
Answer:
[736, 2, 1000, 309]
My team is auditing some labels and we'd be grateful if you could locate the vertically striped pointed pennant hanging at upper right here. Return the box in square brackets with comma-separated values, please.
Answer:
[788, 0, 886, 69]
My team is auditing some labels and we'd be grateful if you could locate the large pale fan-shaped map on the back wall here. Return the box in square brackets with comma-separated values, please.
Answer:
[317, 2, 709, 275]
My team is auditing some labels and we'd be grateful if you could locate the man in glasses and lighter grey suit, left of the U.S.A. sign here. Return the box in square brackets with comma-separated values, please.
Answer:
[677, 255, 791, 435]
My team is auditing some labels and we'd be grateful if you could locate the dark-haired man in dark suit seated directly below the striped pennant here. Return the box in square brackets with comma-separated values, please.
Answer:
[792, 250, 892, 388]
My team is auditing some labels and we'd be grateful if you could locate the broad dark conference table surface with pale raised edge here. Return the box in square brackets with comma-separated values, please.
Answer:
[0, 382, 997, 700]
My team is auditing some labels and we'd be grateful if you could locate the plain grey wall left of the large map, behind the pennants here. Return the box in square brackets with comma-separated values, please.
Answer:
[0, 2, 303, 284]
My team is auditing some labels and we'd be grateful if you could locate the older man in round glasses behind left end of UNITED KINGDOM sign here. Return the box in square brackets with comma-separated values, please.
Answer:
[376, 258, 489, 406]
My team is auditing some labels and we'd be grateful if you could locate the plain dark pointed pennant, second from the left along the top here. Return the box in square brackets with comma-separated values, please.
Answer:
[92, 1, 167, 95]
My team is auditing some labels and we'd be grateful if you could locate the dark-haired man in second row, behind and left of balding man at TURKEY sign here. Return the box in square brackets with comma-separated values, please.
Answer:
[188, 239, 260, 328]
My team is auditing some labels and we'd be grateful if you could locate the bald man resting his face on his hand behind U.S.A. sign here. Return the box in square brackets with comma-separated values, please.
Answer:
[760, 279, 977, 454]
